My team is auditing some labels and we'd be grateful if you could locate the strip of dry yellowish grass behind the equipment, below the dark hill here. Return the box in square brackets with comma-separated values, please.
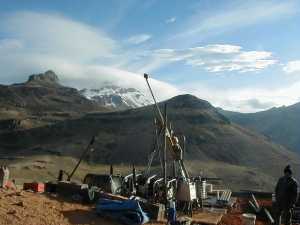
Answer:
[1, 155, 279, 191]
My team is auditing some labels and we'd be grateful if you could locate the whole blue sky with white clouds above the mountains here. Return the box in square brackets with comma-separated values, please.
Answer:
[0, 0, 300, 112]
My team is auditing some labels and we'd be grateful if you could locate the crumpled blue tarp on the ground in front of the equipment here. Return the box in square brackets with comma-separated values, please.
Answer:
[96, 198, 149, 225]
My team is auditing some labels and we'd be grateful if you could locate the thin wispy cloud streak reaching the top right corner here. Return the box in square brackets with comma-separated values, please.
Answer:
[172, 1, 299, 41]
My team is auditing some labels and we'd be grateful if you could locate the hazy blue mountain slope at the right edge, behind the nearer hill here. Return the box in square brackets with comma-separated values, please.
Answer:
[220, 103, 300, 154]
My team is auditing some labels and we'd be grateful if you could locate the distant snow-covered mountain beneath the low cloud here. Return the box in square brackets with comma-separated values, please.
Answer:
[80, 85, 153, 110]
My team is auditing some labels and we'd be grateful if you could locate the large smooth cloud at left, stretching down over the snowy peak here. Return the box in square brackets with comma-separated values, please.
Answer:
[0, 12, 178, 99]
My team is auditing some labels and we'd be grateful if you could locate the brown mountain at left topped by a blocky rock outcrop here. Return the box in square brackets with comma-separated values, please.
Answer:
[0, 70, 107, 132]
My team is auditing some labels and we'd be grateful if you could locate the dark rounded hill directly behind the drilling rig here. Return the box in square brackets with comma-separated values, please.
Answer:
[0, 95, 300, 190]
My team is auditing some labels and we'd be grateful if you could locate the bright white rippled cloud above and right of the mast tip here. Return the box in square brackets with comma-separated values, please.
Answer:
[139, 44, 277, 72]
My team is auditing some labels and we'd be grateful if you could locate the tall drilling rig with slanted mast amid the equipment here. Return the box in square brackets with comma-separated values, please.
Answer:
[136, 74, 197, 211]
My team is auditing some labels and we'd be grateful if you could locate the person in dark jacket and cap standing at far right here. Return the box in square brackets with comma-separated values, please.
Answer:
[275, 165, 298, 225]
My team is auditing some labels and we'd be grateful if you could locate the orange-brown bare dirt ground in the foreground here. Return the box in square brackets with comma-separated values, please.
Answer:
[0, 189, 272, 225]
